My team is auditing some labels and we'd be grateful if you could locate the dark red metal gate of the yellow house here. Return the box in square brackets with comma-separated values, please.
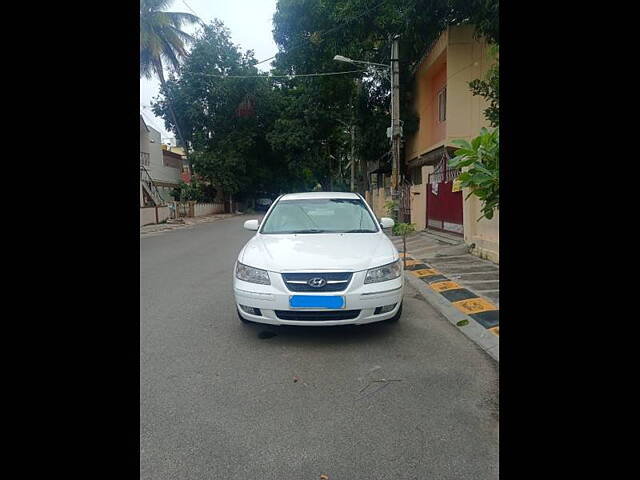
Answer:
[427, 157, 464, 235]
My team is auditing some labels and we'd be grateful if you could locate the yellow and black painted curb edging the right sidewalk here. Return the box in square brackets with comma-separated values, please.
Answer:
[401, 254, 500, 330]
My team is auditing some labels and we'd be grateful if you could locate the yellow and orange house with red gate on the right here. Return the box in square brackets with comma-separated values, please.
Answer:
[403, 25, 499, 262]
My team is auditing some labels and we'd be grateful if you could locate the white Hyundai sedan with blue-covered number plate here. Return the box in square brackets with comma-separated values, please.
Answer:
[233, 192, 404, 326]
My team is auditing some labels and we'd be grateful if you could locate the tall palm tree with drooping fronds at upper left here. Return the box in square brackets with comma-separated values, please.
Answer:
[140, 0, 202, 148]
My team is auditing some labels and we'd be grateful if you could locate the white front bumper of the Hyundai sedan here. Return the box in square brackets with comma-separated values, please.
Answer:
[233, 271, 404, 327]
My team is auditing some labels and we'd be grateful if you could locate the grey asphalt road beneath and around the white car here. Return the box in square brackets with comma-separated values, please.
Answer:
[140, 217, 498, 480]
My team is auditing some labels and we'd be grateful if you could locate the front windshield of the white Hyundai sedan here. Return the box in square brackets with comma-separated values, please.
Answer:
[260, 198, 378, 234]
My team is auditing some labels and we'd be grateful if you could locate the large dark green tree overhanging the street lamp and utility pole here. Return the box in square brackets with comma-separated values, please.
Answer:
[273, 0, 499, 193]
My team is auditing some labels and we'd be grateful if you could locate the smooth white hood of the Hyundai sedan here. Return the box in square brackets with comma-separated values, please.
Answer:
[238, 233, 398, 273]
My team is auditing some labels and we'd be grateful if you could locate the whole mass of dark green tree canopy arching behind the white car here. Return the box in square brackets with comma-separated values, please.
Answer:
[153, 0, 499, 195]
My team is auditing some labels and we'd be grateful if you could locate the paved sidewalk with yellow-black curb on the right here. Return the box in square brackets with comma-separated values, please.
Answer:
[389, 231, 500, 360]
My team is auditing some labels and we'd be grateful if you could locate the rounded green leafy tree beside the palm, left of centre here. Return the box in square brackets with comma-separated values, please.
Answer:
[153, 21, 287, 197]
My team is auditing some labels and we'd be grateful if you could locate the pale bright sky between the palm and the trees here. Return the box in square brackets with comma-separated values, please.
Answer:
[140, 0, 278, 142]
